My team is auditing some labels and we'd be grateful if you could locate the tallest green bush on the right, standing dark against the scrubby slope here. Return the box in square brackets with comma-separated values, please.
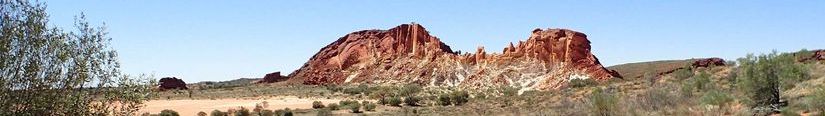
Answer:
[737, 52, 809, 112]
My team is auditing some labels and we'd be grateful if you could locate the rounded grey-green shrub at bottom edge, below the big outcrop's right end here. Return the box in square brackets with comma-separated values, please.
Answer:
[588, 89, 619, 116]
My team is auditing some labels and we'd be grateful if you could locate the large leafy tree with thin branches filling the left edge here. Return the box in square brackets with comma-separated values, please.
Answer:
[0, 0, 151, 116]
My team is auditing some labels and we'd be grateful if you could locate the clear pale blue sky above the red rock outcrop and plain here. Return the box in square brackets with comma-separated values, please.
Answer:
[46, 0, 825, 82]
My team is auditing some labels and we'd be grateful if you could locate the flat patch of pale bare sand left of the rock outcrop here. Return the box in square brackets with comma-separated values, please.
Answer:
[139, 96, 340, 116]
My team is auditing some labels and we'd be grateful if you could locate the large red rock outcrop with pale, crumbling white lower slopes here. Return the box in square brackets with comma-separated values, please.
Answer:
[289, 24, 621, 90]
